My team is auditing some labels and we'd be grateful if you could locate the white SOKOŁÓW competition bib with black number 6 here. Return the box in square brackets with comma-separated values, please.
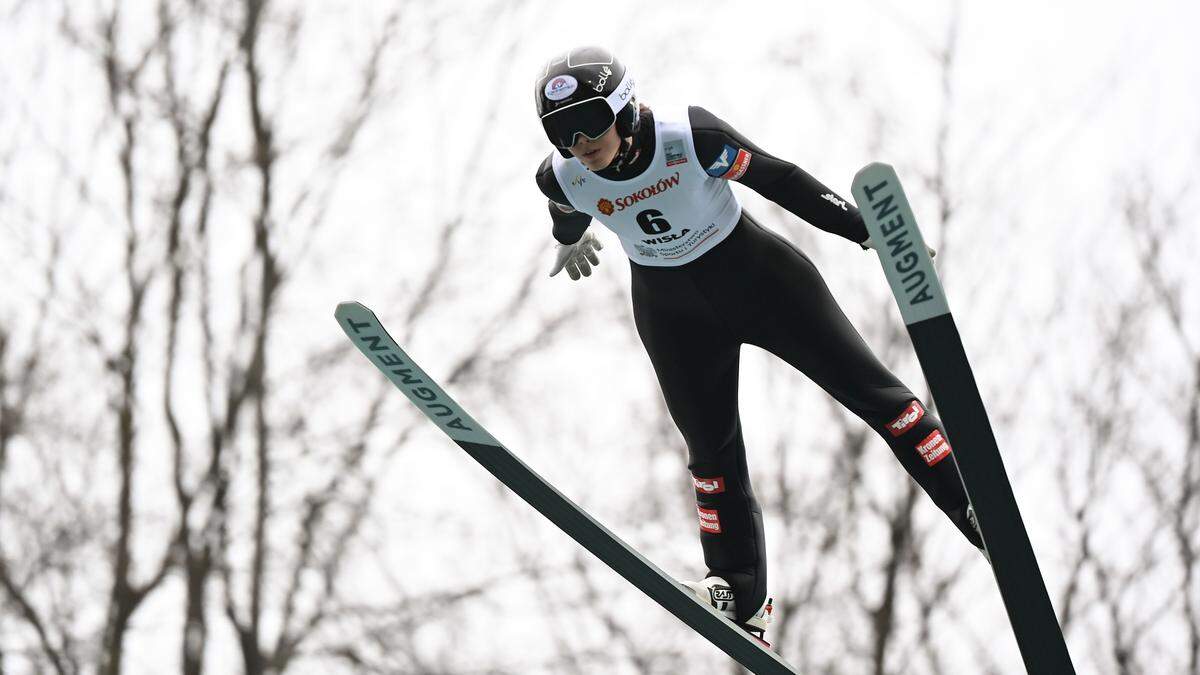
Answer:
[551, 109, 742, 267]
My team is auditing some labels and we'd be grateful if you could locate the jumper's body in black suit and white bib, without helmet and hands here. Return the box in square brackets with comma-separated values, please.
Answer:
[538, 106, 982, 622]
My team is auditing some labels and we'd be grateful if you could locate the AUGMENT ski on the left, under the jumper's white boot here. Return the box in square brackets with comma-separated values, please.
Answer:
[335, 301, 797, 675]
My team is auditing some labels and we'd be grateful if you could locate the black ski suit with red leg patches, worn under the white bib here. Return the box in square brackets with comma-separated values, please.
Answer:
[538, 106, 982, 622]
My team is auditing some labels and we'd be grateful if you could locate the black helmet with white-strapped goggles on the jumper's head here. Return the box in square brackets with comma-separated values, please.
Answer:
[534, 47, 637, 157]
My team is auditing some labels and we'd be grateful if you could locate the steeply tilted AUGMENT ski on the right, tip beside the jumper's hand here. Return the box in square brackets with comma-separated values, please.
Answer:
[852, 163, 1075, 675]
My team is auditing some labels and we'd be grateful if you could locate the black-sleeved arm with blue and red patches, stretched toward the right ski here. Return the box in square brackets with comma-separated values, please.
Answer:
[688, 106, 868, 245]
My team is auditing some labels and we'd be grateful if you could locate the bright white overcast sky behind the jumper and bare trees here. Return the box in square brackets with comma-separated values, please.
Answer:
[0, 0, 1200, 673]
